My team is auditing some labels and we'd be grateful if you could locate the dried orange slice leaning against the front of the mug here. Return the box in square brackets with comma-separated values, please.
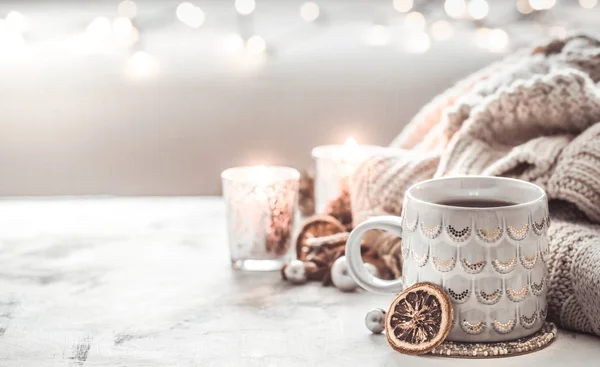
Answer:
[385, 283, 453, 354]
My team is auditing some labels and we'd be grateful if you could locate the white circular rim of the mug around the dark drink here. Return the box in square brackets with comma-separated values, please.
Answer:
[406, 175, 546, 211]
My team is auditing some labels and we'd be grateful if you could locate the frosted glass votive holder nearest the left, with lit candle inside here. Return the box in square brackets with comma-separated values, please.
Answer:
[221, 166, 300, 271]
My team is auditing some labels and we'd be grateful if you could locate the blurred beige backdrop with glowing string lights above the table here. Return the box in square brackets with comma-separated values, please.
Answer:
[0, 0, 600, 196]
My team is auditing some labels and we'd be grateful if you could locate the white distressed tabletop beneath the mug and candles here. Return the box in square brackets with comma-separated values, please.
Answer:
[0, 198, 600, 367]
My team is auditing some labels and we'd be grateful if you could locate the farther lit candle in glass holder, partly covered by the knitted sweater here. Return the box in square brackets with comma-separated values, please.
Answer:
[312, 137, 381, 226]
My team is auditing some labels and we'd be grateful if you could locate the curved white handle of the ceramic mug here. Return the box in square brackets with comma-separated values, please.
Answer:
[346, 215, 404, 293]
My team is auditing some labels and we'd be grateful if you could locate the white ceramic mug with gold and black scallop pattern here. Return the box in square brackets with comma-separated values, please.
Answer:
[346, 176, 550, 342]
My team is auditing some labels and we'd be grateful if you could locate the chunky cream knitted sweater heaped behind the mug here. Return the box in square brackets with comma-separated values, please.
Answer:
[351, 35, 600, 335]
